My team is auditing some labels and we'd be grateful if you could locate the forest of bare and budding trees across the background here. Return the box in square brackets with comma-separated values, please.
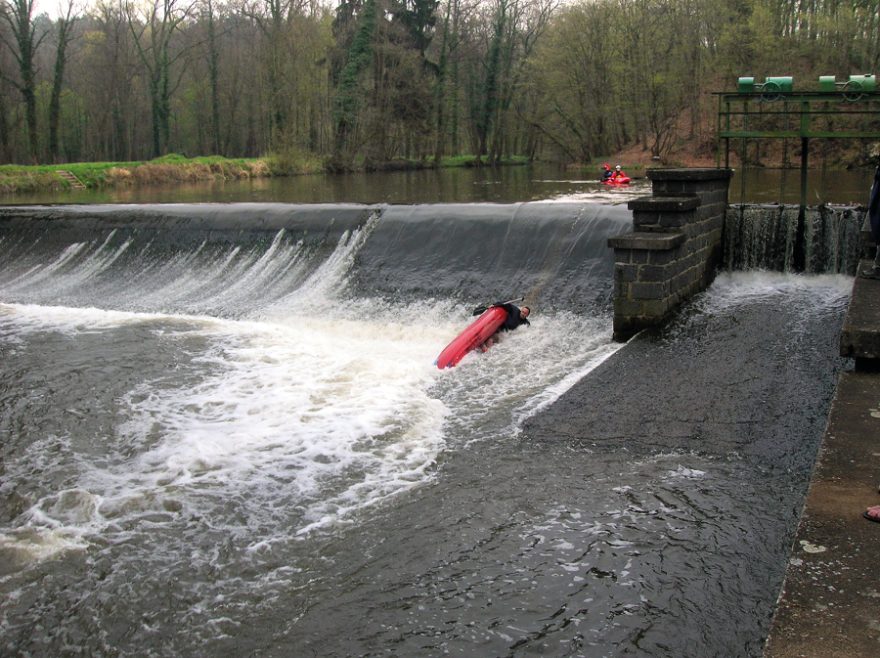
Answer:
[0, 0, 880, 171]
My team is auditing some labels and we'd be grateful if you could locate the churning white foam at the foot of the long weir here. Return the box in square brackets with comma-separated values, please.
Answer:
[0, 206, 618, 550]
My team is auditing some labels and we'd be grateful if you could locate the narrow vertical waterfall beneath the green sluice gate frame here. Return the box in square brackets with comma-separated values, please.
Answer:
[724, 204, 865, 275]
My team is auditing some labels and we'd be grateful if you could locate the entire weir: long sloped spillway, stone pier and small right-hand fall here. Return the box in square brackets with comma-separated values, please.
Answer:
[0, 191, 865, 328]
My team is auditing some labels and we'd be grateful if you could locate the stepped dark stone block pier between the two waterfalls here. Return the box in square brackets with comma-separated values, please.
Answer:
[608, 168, 733, 340]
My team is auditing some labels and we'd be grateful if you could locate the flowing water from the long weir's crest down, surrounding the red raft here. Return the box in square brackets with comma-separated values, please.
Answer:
[0, 163, 851, 656]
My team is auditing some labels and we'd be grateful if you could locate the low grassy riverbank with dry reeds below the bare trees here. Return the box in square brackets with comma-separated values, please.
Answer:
[0, 153, 528, 198]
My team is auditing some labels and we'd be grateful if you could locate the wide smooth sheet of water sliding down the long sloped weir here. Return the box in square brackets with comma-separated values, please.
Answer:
[0, 202, 630, 317]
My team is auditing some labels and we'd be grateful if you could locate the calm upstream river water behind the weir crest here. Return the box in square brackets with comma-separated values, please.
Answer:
[0, 164, 873, 205]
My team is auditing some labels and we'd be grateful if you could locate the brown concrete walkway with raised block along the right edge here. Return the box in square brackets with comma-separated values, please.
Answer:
[764, 264, 880, 658]
